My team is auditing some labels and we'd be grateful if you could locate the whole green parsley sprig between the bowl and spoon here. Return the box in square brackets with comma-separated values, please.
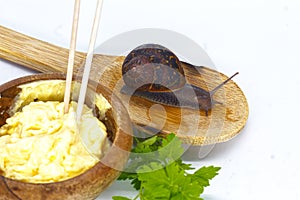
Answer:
[113, 134, 221, 200]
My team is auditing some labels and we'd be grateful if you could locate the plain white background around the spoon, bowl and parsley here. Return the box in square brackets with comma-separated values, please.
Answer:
[0, 0, 300, 200]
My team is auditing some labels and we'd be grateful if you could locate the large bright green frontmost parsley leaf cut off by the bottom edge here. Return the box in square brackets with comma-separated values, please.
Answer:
[137, 162, 203, 200]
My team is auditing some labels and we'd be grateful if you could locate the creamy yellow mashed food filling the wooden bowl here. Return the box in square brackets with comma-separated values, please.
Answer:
[0, 80, 108, 183]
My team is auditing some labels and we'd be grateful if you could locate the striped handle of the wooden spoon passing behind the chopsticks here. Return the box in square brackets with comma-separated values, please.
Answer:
[0, 26, 85, 72]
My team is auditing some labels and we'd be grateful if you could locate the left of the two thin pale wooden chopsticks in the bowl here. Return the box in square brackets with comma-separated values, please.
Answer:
[64, 0, 80, 113]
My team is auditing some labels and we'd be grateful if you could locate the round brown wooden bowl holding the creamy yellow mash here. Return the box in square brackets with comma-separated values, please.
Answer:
[0, 73, 132, 200]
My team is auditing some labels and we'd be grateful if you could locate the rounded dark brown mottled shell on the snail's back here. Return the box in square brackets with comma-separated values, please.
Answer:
[122, 44, 186, 92]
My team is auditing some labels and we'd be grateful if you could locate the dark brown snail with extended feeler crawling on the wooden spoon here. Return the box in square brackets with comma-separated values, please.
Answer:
[121, 44, 238, 116]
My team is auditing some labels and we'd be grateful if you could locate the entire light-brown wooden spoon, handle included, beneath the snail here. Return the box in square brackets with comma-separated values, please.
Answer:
[0, 26, 249, 145]
